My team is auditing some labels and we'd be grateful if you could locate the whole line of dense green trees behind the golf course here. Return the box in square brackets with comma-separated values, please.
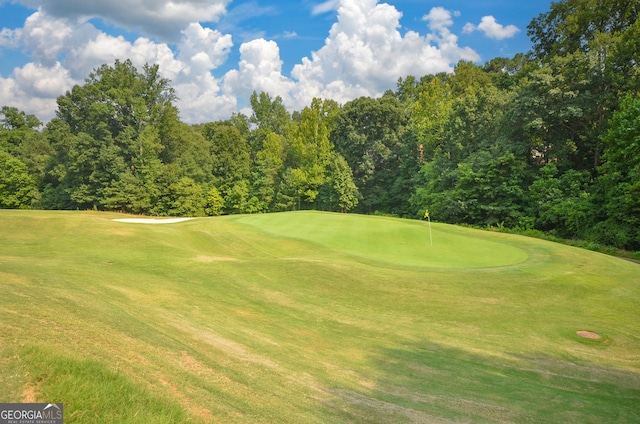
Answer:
[0, 0, 640, 250]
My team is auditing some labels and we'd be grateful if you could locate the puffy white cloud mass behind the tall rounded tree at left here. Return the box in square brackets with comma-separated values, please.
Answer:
[0, 10, 236, 122]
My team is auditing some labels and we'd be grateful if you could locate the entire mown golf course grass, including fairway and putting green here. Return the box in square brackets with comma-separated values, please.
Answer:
[0, 210, 640, 423]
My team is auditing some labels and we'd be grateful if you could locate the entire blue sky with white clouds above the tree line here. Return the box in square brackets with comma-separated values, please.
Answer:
[0, 0, 551, 123]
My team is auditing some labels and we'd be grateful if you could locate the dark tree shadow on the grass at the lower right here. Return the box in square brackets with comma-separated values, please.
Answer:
[334, 342, 640, 424]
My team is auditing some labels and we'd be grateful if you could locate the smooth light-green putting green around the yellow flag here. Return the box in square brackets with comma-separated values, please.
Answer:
[236, 211, 528, 269]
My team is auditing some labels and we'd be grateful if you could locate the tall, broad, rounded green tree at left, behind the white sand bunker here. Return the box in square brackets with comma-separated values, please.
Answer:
[44, 61, 182, 213]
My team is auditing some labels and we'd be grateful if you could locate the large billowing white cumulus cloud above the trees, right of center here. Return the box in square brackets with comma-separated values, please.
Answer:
[291, 0, 480, 108]
